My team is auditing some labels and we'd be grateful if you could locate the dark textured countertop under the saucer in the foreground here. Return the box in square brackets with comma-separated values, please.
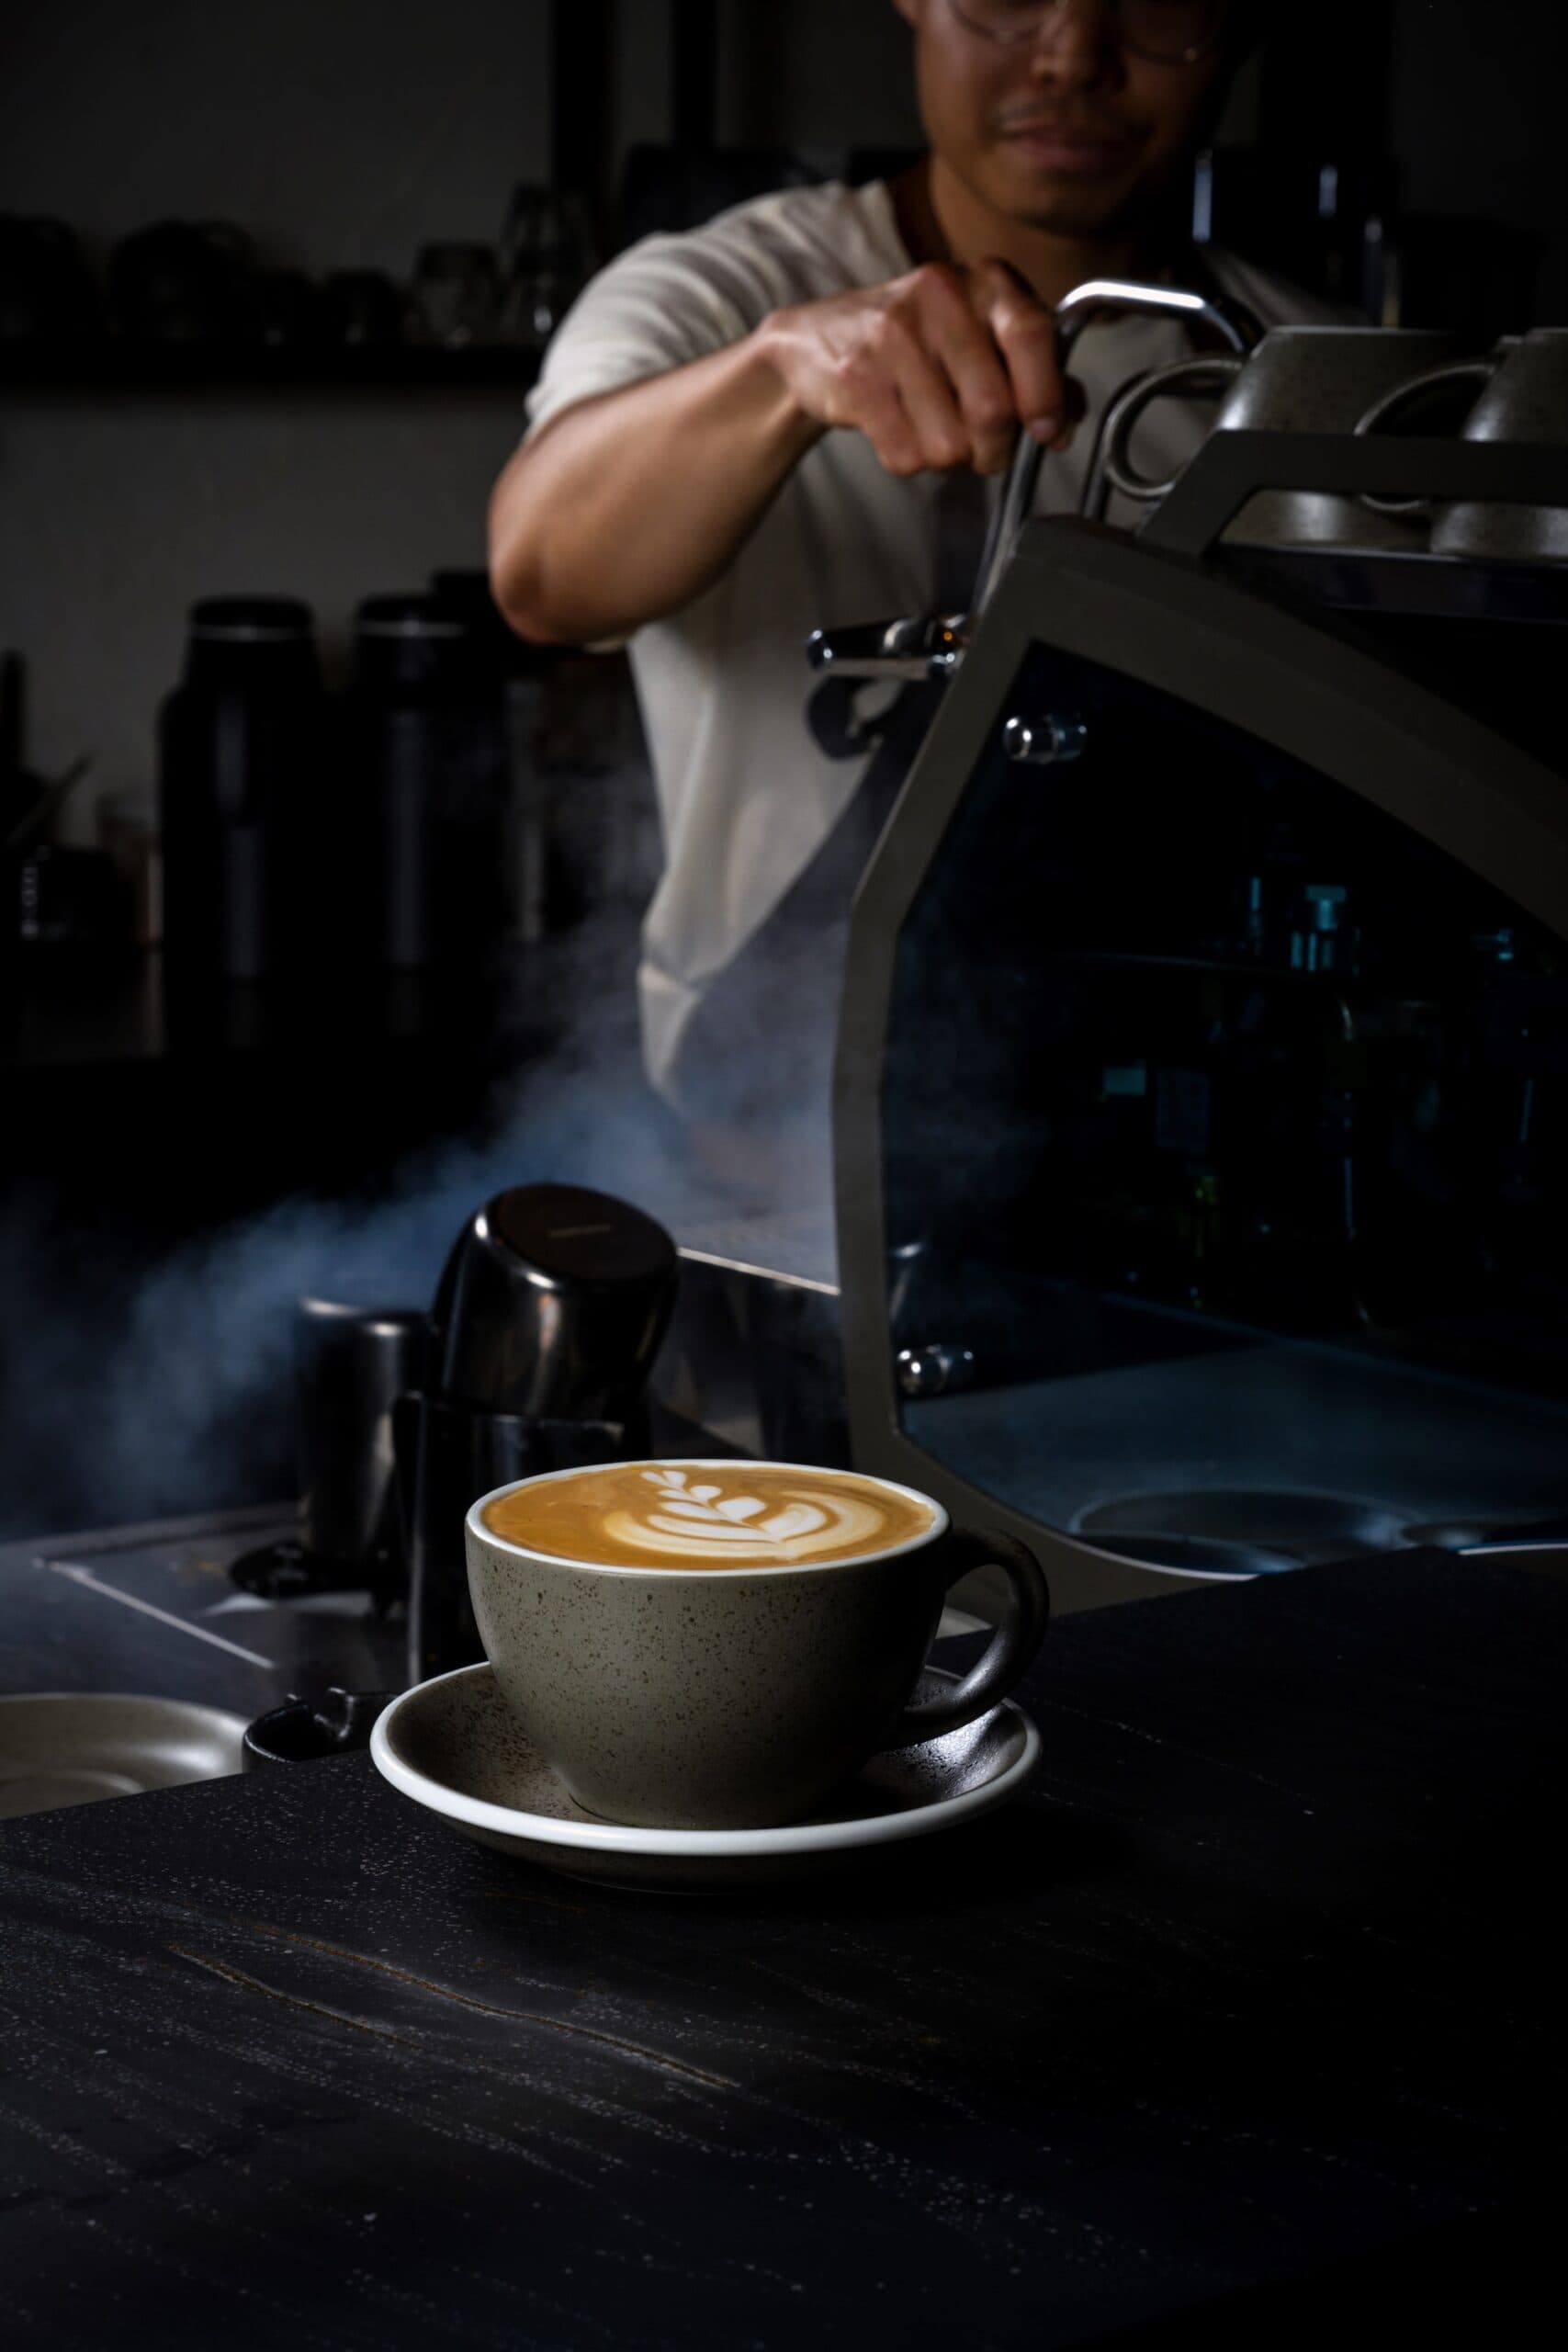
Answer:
[0, 1555, 1568, 2352]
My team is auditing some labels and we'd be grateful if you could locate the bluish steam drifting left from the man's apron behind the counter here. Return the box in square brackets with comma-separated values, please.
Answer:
[0, 898, 825, 1536]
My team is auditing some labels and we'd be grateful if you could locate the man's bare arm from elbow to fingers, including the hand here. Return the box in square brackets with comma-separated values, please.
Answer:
[489, 261, 1067, 644]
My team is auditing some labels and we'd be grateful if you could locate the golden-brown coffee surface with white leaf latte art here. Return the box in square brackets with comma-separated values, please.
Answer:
[482, 1463, 936, 1569]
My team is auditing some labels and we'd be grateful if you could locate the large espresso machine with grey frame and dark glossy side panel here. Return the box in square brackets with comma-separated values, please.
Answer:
[658, 297, 1568, 1609]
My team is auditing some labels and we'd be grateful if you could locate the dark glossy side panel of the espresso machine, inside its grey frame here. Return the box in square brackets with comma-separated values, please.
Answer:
[882, 647, 1568, 1576]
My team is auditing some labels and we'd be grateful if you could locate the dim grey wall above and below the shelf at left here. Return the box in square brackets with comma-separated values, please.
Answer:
[0, 0, 550, 840]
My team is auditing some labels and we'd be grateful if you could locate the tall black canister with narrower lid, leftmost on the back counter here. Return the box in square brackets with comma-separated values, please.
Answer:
[160, 597, 332, 1009]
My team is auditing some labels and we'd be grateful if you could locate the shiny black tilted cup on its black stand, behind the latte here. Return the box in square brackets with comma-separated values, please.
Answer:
[392, 1183, 677, 1681]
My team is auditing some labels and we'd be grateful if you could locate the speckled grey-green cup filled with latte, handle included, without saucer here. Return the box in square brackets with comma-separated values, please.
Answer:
[466, 1461, 1048, 1830]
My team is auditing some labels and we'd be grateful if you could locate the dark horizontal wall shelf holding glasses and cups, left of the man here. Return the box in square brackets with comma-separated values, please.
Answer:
[0, 344, 538, 400]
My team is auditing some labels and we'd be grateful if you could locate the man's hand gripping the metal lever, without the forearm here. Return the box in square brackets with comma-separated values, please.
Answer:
[755, 261, 1081, 475]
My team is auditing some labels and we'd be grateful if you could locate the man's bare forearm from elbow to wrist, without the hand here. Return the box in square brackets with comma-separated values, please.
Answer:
[489, 336, 823, 644]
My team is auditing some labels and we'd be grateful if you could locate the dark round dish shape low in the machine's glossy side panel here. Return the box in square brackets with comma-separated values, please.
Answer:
[1072, 1487, 1411, 1576]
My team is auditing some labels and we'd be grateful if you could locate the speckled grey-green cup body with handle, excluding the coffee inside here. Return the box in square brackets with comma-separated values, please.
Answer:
[466, 1463, 1048, 1830]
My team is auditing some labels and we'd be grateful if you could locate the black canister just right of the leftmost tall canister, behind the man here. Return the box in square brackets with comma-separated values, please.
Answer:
[348, 595, 508, 974]
